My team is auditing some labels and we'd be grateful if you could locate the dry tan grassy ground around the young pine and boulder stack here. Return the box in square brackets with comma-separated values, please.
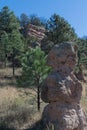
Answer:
[0, 68, 87, 130]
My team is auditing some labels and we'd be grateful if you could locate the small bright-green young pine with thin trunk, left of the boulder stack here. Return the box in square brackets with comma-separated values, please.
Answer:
[18, 47, 51, 110]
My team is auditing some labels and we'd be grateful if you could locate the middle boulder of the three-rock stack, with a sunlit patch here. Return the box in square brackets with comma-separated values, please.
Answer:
[41, 71, 82, 103]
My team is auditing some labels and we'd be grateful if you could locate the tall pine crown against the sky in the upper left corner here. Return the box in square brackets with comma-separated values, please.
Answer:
[0, 6, 19, 34]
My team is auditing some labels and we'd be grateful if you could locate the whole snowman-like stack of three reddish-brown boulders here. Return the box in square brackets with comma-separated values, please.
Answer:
[41, 43, 87, 130]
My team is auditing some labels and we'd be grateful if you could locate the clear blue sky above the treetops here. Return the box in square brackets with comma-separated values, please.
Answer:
[0, 0, 87, 37]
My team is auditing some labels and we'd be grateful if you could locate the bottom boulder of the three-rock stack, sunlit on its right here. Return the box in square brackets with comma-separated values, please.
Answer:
[43, 102, 87, 130]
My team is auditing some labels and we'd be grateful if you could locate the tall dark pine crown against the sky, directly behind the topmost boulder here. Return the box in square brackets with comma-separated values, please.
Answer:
[46, 14, 77, 44]
